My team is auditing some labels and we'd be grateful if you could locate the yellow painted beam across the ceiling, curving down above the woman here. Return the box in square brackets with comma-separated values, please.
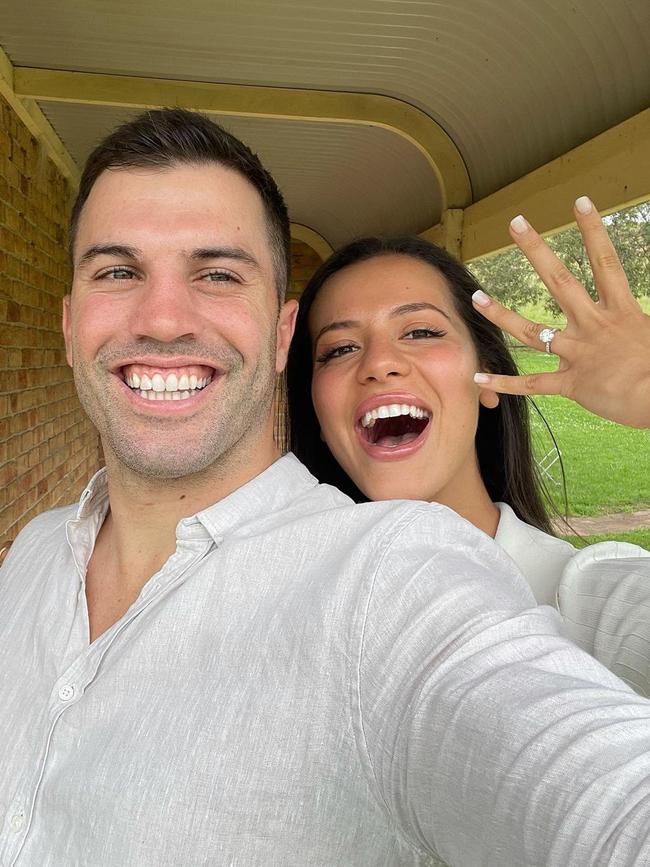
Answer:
[14, 67, 472, 209]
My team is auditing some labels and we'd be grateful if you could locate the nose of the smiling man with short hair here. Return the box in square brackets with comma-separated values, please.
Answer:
[131, 274, 197, 343]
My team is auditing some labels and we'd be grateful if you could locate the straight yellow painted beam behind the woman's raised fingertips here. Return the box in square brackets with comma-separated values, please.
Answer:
[462, 109, 650, 260]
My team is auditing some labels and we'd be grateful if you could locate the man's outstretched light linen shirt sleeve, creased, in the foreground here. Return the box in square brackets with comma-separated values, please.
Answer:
[358, 512, 650, 867]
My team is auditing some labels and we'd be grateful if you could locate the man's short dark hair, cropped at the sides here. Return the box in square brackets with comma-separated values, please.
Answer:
[69, 108, 291, 301]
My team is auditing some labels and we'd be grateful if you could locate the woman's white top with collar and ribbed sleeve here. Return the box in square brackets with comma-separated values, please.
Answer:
[495, 503, 650, 696]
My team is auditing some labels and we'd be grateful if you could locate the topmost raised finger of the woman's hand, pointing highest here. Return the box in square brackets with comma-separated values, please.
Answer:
[574, 196, 633, 308]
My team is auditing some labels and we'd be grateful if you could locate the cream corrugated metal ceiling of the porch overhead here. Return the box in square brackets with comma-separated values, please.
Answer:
[0, 0, 650, 242]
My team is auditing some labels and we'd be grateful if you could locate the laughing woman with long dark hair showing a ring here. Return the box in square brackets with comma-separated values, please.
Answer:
[288, 198, 650, 692]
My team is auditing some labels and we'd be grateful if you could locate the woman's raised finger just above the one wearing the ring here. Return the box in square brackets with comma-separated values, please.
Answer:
[510, 214, 593, 320]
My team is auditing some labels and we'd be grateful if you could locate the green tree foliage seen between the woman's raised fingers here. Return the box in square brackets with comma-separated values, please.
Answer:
[469, 202, 650, 319]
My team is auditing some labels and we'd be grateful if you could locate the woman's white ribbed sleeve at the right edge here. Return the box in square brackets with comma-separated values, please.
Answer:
[558, 542, 650, 696]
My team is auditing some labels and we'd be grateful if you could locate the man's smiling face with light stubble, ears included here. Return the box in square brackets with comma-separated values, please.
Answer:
[63, 164, 295, 479]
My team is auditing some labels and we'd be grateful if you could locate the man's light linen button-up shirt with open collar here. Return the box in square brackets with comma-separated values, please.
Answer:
[5, 455, 650, 867]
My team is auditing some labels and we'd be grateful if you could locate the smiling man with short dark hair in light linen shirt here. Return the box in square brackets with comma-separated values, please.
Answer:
[0, 110, 650, 867]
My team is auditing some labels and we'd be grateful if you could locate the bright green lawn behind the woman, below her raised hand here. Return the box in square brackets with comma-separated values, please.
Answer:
[515, 350, 650, 520]
